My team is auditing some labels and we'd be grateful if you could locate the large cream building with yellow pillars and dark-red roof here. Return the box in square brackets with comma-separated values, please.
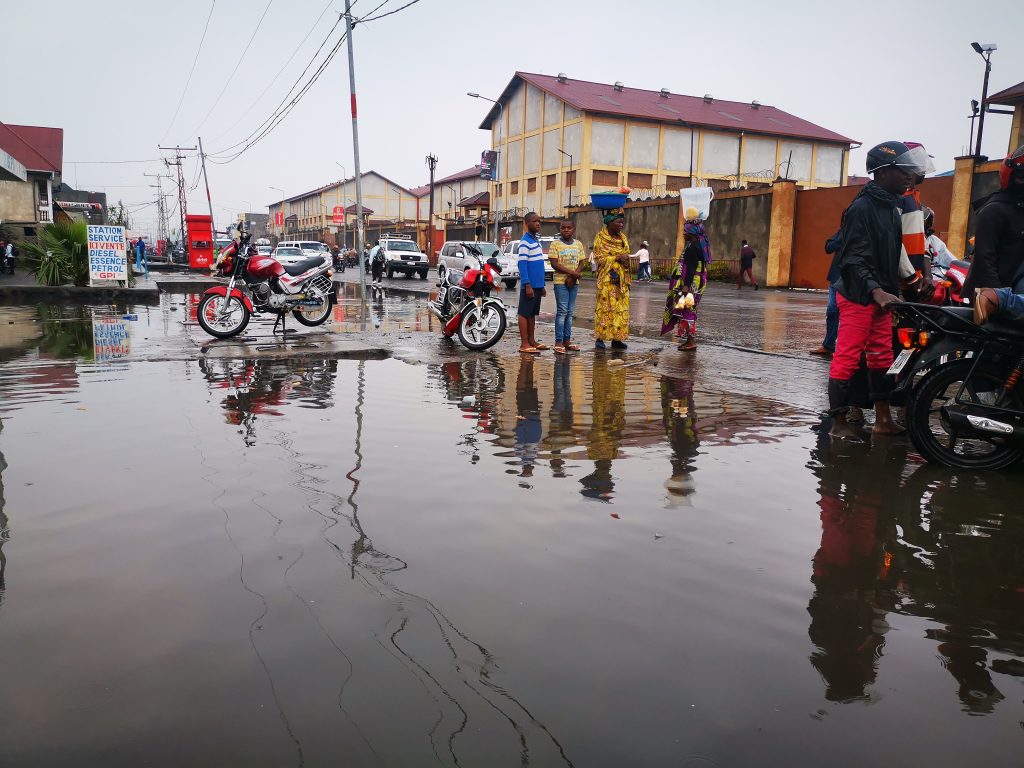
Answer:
[480, 72, 856, 216]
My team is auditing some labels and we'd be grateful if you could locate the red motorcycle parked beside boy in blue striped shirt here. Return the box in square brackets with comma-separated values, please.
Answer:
[427, 244, 508, 352]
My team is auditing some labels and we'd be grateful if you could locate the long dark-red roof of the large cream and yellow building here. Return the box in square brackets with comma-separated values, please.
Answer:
[480, 72, 856, 144]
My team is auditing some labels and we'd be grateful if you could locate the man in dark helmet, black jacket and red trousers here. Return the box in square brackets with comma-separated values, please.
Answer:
[828, 141, 925, 441]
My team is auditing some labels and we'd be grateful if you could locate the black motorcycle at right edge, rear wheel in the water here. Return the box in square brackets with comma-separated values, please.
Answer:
[889, 303, 1024, 469]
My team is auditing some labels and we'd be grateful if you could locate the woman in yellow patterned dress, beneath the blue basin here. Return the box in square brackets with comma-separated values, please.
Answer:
[593, 208, 631, 349]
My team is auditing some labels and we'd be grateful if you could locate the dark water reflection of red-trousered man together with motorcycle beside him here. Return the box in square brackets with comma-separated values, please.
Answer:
[807, 438, 1024, 715]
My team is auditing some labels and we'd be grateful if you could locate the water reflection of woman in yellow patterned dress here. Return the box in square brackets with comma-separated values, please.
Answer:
[580, 357, 626, 502]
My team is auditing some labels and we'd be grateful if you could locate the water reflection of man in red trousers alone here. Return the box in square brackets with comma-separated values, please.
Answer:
[807, 434, 889, 701]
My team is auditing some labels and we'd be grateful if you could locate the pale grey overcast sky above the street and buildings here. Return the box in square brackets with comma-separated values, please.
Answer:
[0, 0, 1024, 234]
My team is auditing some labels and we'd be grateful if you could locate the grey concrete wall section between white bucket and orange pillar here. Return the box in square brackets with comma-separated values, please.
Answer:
[705, 188, 771, 285]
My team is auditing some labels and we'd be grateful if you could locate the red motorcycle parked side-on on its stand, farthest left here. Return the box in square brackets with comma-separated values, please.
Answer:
[197, 232, 334, 339]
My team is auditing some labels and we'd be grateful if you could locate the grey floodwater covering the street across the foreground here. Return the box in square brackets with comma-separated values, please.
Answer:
[0, 302, 1024, 766]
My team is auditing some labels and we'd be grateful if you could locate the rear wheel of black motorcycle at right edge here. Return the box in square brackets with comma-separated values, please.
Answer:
[906, 359, 1024, 469]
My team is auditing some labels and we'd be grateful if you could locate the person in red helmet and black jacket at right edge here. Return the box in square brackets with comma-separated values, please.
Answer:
[964, 146, 1024, 319]
